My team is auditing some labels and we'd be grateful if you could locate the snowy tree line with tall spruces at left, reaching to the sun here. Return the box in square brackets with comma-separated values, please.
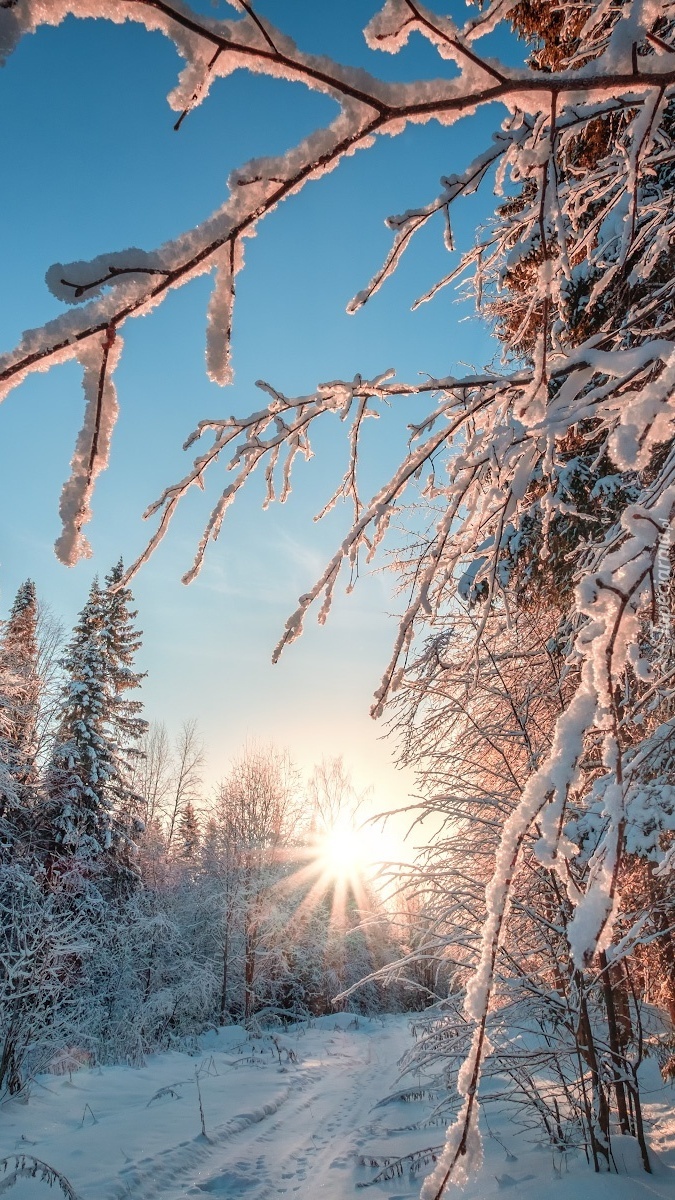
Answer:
[0, 563, 418, 1096]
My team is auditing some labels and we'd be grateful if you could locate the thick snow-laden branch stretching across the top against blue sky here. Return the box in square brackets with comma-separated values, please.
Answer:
[0, 0, 675, 554]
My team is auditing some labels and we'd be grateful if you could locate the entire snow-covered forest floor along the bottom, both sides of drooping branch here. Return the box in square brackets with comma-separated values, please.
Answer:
[0, 1014, 675, 1200]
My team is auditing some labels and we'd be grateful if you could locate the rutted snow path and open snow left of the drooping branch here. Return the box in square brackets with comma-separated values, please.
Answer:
[0, 1014, 411, 1200]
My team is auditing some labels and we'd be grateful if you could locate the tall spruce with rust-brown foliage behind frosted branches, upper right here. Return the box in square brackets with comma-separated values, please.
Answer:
[468, 0, 675, 617]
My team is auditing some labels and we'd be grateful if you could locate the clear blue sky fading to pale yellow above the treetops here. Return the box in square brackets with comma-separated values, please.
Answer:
[0, 0, 515, 844]
